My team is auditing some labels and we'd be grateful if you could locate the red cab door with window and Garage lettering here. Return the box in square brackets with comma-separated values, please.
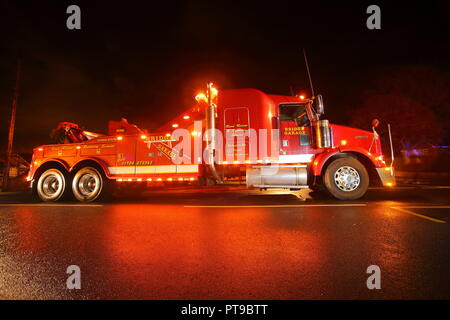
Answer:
[279, 103, 312, 163]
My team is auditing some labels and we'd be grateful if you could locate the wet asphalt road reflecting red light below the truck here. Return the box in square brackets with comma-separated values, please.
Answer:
[0, 187, 450, 299]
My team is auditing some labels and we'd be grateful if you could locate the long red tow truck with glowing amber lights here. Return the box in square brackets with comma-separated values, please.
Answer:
[27, 84, 395, 202]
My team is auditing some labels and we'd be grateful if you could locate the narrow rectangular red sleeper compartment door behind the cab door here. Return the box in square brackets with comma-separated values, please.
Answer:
[224, 107, 250, 162]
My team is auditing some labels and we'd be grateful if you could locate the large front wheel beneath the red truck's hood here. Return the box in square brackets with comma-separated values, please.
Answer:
[323, 158, 369, 200]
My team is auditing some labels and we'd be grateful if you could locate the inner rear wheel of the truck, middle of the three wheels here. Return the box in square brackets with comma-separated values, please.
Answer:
[72, 167, 111, 202]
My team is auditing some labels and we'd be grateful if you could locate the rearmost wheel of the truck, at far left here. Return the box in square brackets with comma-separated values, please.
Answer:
[36, 168, 71, 202]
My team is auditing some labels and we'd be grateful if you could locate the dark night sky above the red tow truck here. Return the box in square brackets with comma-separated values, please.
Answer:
[0, 0, 450, 152]
